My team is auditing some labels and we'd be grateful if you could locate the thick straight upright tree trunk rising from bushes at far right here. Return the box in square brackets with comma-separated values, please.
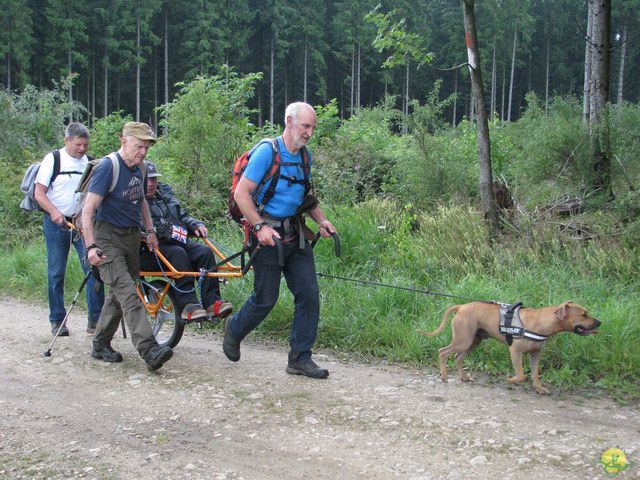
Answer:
[589, 0, 613, 198]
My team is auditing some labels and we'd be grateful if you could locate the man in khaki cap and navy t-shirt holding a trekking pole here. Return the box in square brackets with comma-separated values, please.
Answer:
[82, 122, 173, 371]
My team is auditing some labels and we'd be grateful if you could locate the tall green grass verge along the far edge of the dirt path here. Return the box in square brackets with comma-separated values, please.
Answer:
[6, 201, 640, 398]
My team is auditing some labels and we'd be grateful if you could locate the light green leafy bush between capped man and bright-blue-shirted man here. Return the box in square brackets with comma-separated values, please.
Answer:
[150, 67, 260, 220]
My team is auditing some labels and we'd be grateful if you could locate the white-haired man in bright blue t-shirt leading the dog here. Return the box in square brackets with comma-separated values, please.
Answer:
[222, 102, 336, 378]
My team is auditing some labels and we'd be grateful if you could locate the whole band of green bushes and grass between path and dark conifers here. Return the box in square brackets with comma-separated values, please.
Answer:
[0, 70, 640, 395]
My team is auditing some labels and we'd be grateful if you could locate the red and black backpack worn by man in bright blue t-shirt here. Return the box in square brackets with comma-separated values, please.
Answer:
[228, 138, 311, 223]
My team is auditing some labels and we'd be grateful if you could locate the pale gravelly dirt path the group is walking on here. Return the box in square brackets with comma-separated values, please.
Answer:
[0, 301, 640, 480]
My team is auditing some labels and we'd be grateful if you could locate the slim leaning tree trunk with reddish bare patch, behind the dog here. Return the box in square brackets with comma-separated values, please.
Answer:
[464, 0, 498, 239]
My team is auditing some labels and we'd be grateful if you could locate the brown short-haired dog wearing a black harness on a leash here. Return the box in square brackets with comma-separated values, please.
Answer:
[418, 301, 600, 395]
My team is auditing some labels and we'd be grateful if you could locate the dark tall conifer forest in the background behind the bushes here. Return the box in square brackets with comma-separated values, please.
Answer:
[0, 0, 640, 127]
